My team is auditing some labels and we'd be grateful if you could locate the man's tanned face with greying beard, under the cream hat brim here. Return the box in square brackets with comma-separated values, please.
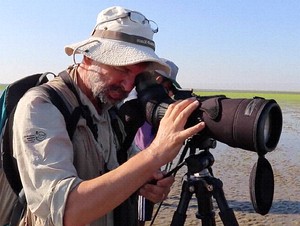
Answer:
[88, 62, 147, 104]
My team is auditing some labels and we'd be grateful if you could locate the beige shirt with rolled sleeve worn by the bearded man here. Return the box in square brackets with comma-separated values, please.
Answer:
[13, 71, 123, 226]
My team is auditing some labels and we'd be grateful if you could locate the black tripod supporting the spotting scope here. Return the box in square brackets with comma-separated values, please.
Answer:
[171, 137, 238, 226]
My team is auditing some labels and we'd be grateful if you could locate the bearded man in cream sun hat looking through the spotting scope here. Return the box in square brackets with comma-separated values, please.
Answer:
[13, 7, 204, 226]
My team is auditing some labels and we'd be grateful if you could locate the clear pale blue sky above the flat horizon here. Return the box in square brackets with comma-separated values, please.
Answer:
[0, 0, 300, 92]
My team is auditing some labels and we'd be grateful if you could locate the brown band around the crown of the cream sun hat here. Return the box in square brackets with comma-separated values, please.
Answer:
[92, 30, 155, 51]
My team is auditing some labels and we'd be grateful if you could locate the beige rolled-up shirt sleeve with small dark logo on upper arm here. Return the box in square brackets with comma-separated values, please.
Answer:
[13, 91, 82, 225]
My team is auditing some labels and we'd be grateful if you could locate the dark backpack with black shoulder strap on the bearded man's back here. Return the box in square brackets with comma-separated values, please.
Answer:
[0, 72, 97, 225]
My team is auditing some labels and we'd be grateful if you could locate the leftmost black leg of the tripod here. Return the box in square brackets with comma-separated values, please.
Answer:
[171, 181, 193, 226]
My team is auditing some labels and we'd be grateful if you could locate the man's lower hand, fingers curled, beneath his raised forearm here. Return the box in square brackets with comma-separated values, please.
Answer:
[140, 171, 174, 203]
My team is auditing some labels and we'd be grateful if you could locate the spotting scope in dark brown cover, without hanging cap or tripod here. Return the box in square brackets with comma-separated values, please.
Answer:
[135, 72, 282, 156]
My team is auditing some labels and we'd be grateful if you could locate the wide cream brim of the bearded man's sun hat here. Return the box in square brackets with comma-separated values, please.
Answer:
[65, 37, 170, 73]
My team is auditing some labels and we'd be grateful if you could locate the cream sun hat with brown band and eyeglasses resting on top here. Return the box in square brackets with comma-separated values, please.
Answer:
[65, 6, 170, 73]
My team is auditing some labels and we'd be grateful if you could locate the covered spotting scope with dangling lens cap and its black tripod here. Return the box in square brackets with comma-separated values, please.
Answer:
[135, 72, 282, 219]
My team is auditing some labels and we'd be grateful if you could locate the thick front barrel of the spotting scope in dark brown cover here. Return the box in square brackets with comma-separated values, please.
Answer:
[202, 97, 282, 154]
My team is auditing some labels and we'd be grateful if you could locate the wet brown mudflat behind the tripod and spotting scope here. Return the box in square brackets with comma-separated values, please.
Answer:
[147, 103, 300, 226]
